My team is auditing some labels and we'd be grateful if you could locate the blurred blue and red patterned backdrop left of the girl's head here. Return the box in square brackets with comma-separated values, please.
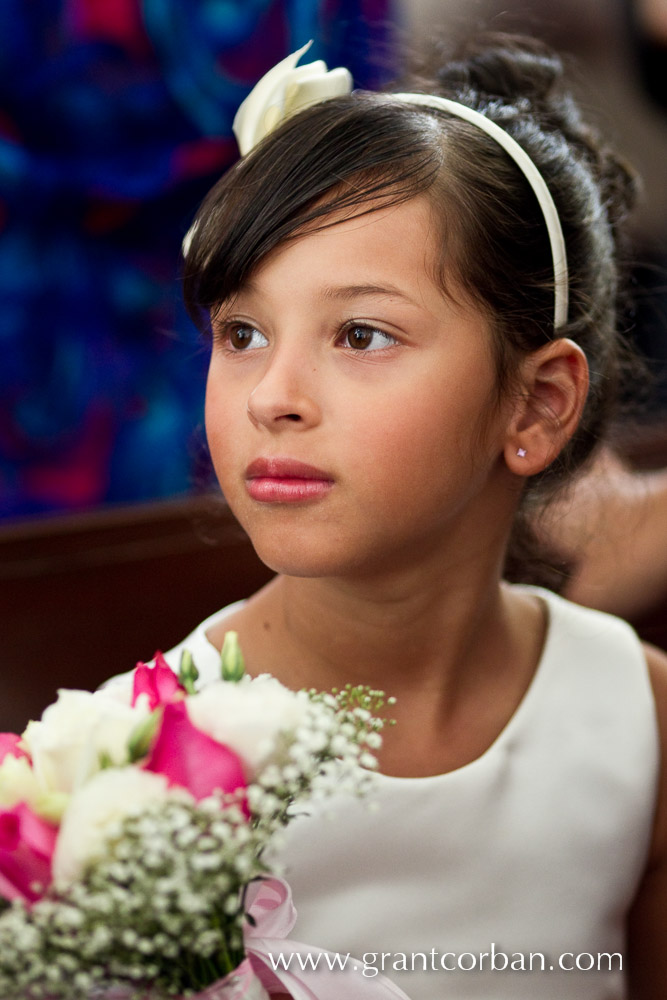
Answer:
[0, 0, 397, 520]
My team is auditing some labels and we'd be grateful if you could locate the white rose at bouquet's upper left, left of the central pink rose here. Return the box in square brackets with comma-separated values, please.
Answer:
[21, 690, 149, 794]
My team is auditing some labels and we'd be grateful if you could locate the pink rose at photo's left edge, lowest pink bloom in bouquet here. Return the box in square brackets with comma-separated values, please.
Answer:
[0, 802, 58, 903]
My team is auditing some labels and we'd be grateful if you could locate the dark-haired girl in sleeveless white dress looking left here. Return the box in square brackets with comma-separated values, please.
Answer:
[172, 37, 667, 1000]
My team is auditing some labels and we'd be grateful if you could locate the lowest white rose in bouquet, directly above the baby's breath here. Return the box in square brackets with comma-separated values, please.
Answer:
[53, 767, 180, 885]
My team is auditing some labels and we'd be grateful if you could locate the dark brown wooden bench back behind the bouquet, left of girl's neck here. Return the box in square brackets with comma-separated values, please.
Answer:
[0, 498, 271, 731]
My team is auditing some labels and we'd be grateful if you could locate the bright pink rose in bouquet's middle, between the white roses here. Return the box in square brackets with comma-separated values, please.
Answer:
[144, 701, 247, 799]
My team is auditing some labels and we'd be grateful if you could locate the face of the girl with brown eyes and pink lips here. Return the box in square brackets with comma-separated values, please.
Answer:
[206, 197, 520, 578]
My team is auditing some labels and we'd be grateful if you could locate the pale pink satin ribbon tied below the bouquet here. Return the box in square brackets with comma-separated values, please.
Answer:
[243, 877, 409, 1000]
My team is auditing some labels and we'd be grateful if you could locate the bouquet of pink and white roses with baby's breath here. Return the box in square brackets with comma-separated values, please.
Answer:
[0, 633, 400, 1000]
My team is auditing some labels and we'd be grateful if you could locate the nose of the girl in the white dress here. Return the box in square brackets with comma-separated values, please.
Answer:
[247, 357, 321, 430]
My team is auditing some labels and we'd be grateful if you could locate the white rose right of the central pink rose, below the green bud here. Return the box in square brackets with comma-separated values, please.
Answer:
[185, 674, 310, 778]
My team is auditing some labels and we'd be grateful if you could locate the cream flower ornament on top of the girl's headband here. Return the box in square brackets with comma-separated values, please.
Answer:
[232, 42, 352, 156]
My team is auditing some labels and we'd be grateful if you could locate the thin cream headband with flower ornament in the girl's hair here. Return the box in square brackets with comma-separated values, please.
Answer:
[188, 42, 569, 329]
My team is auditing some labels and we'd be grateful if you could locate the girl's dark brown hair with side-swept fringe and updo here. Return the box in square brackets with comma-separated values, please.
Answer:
[184, 35, 634, 586]
